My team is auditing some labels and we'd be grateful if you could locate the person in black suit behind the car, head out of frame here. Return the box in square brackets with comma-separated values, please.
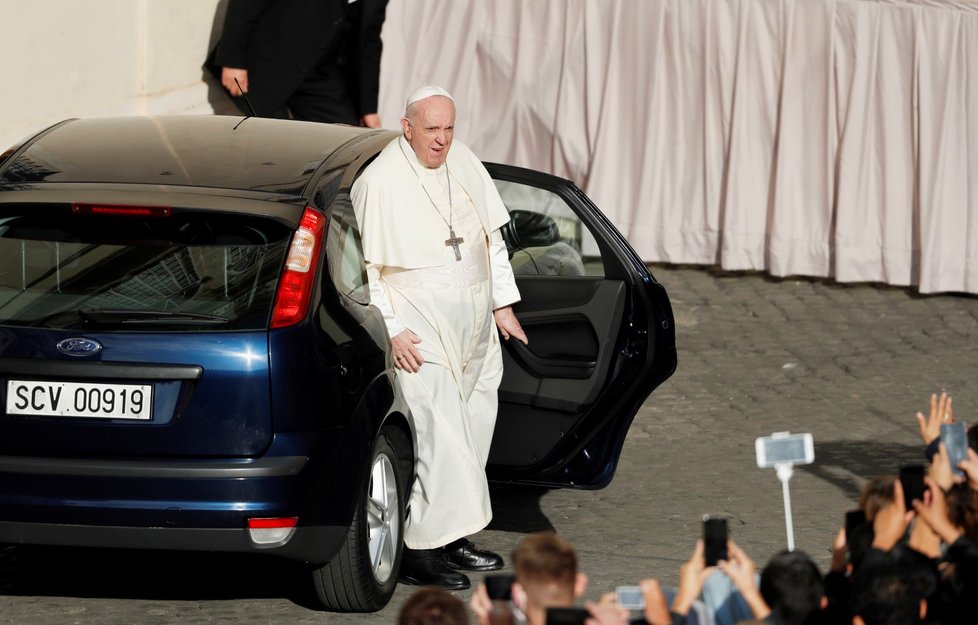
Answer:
[213, 0, 387, 128]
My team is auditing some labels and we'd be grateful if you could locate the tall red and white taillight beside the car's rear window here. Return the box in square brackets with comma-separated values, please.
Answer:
[272, 207, 326, 328]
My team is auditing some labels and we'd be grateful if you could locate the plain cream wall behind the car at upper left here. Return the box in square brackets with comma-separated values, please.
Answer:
[0, 0, 231, 151]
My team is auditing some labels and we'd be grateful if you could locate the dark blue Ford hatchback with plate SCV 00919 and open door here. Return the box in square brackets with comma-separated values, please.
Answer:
[0, 116, 676, 611]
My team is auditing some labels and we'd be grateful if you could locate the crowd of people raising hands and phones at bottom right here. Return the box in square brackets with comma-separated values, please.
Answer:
[398, 393, 978, 625]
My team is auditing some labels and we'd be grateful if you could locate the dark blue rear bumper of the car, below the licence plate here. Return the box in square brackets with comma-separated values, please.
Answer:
[0, 439, 356, 564]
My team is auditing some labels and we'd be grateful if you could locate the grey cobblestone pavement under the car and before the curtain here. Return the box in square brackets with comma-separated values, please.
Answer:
[0, 267, 978, 625]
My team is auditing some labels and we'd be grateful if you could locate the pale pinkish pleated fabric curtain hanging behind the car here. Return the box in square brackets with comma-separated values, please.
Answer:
[380, 0, 978, 293]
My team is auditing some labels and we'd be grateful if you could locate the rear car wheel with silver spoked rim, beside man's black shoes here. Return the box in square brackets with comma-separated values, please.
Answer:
[313, 428, 410, 612]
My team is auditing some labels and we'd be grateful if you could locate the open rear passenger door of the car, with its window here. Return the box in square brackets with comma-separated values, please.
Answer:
[487, 163, 676, 488]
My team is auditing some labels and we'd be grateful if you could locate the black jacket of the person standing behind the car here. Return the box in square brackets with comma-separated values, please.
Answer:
[214, 0, 387, 116]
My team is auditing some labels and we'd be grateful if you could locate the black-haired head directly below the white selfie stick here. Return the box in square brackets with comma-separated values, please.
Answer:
[761, 551, 823, 625]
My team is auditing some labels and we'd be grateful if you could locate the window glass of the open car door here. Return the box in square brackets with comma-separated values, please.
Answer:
[494, 180, 604, 276]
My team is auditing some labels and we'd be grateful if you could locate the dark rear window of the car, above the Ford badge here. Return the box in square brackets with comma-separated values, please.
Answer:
[0, 206, 292, 331]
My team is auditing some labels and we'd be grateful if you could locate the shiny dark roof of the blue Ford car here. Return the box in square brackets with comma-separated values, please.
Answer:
[0, 115, 386, 196]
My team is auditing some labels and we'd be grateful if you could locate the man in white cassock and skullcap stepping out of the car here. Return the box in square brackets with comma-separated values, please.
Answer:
[351, 86, 526, 589]
